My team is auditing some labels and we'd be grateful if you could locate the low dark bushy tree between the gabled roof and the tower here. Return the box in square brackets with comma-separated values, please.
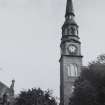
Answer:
[15, 88, 56, 105]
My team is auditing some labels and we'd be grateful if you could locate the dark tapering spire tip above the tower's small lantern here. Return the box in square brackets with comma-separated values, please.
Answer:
[65, 0, 75, 17]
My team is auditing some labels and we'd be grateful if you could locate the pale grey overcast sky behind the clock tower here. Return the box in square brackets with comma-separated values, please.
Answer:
[0, 0, 105, 96]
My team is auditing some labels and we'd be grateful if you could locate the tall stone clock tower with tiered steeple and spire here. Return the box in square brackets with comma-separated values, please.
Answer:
[60, 0, 82, 105]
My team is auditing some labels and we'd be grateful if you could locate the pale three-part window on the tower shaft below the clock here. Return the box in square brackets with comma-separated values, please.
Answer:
[67, 64, 78, 77]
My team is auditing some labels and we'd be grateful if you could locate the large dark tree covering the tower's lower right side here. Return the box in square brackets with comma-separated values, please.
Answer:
[69, 55, 105, 105]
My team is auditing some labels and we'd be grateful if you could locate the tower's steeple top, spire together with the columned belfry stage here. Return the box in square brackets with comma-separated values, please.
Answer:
[62, 0, 78, 37]
